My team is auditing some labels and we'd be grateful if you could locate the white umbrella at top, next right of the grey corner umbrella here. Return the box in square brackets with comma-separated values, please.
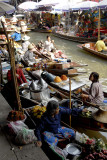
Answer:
[18, 1, 38, 11]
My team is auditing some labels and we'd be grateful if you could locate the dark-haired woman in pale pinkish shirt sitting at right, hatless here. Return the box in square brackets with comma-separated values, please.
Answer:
[81, 72, 104, 104]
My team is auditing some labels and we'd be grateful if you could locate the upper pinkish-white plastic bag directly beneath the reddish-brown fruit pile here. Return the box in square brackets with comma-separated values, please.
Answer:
[8, 121, 28, 134]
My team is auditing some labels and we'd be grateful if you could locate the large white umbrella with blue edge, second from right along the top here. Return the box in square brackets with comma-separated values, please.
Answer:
[70, 1, 98, 10]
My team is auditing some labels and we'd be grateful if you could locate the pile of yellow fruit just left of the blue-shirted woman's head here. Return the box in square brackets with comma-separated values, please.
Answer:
[32, 106, 46, 119]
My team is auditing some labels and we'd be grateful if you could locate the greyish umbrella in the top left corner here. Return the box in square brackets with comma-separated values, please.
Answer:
[0, 2, 15, 14]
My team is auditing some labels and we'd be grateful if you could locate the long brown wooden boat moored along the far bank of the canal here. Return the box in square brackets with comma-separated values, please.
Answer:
[52, 32, 97, 43]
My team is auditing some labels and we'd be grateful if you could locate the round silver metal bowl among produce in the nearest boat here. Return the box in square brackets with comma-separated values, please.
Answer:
[66, 143, 82, 156]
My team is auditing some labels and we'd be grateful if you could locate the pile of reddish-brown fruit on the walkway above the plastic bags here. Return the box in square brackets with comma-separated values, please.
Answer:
[7, 110, 25, 121]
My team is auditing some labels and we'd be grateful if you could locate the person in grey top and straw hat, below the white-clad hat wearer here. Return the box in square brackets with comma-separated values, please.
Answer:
[23, 44, 35, 64]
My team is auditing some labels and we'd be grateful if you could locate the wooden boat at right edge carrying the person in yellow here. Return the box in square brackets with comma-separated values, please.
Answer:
[78, 42, 107, 59]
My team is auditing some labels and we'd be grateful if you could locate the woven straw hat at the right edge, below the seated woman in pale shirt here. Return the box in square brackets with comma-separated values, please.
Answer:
[92, 106, 107, 123]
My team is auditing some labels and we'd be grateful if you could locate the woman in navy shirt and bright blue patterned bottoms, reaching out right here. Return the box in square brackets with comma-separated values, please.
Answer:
[35, 100, 75, 147]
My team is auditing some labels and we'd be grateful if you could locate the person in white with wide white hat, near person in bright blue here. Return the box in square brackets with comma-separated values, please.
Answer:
[22, 35, 30, 52]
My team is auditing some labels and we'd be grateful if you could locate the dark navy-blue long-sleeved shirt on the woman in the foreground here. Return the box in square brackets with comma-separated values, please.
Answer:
[36, 108, 72, 141]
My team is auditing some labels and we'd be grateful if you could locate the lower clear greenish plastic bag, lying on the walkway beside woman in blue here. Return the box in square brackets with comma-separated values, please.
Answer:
[15, 128, 37, 145]
